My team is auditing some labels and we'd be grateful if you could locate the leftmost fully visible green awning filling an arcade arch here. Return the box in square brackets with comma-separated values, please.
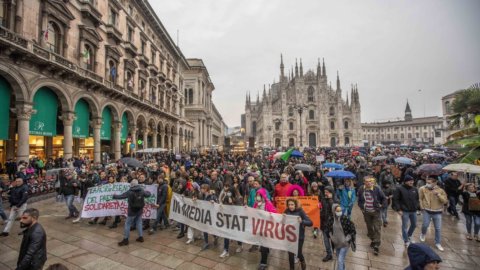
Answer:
[30, 87, 58, 136]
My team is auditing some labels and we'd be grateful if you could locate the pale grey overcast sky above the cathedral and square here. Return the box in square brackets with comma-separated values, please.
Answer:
[150, 0, 480, 127]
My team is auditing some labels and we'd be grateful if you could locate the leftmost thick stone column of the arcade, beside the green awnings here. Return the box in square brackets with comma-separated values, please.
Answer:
[15, 105, 36, 162]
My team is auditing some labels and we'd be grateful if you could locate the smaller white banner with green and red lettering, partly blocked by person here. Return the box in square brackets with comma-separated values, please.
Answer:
[82, 183, 157, 219]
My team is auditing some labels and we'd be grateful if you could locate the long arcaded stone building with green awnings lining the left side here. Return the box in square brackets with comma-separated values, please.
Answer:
[0, 0, 225, 162]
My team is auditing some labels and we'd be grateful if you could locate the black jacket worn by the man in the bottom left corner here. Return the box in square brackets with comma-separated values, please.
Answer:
[16, 223, 47, 270]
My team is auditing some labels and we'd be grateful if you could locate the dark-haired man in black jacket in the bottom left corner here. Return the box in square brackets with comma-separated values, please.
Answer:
[16, 208, 47, 270]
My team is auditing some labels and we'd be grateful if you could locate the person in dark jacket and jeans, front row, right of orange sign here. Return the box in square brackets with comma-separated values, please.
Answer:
[327, 203, 356, 270]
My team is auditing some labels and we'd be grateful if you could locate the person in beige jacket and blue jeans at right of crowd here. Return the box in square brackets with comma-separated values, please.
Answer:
[418, 177, 448, 251]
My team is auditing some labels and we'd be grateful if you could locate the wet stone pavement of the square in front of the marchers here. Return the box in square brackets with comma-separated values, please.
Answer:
[0, 198, 480, 270]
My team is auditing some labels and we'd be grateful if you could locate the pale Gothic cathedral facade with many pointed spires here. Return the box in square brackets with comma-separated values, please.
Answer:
[244, 57, 362, 147]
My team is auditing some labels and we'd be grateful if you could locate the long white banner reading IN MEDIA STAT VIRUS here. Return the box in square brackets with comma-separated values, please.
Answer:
[169, 193, 300, 253]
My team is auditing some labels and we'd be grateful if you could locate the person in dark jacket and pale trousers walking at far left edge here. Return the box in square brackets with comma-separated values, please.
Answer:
[0, 178, 28, 236]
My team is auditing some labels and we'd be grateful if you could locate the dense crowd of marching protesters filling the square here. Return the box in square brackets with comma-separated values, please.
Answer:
[0, 147, 480, 269]
